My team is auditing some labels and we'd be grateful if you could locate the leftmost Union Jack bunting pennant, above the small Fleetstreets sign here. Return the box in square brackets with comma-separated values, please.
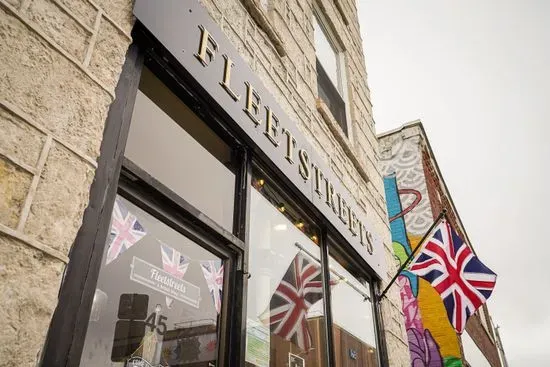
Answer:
[105, 197, 147, 265]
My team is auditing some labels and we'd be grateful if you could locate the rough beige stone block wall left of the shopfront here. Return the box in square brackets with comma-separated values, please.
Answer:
[0, 0, 133, 366]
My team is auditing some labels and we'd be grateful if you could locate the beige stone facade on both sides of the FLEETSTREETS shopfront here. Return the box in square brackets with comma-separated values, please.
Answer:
[0, 0, 409, 366]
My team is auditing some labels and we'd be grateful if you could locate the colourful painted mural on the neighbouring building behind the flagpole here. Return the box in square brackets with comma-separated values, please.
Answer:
[382, 136, 463, 367]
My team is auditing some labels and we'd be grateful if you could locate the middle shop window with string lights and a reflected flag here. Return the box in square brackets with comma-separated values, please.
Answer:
[246, 173, 326, 367]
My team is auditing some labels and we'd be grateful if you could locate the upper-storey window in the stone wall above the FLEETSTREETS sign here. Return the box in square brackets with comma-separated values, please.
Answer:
[313, 15, 348, 135]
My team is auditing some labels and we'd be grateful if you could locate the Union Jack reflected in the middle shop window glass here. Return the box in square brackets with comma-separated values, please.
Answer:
[260, 253, 323, 351]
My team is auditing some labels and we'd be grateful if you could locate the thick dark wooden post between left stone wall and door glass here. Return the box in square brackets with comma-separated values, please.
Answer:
[40, 44, 143, 366]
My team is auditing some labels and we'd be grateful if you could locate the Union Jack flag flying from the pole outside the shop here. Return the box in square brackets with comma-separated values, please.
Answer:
[409, 221, 497, 334]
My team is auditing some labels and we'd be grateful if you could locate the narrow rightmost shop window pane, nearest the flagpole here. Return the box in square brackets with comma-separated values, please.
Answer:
[329, 249, 378, 367]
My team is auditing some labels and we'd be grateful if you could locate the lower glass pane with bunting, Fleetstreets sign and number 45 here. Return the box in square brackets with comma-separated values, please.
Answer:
[81, 197, 223, 367]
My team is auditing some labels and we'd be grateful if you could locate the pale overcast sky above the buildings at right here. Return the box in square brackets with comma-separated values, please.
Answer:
[358, 0, 550, 367]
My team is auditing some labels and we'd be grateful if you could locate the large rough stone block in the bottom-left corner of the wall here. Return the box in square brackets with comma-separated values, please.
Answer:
[0, 234, 63, 366]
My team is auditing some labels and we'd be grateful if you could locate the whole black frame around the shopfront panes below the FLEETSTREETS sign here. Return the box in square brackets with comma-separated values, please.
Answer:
[40, 22, 388, 366]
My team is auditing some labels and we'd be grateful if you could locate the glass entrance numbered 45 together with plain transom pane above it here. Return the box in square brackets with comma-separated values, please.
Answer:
[81, 67, 240, 367]
